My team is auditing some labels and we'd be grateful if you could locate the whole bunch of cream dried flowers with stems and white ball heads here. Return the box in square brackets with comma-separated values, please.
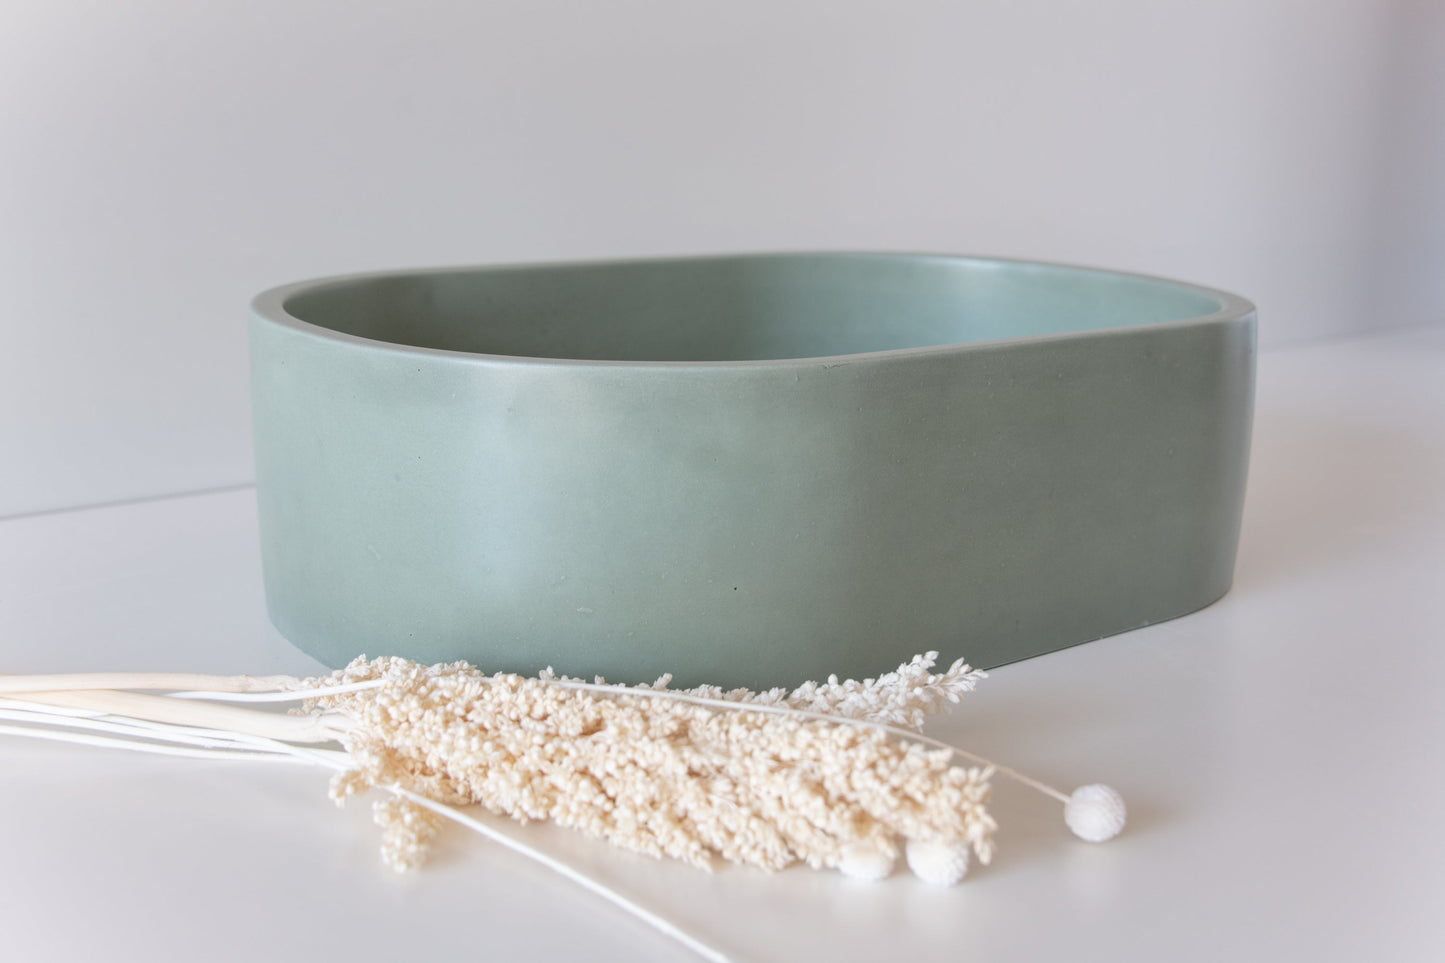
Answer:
[0, 652, 1124, 962]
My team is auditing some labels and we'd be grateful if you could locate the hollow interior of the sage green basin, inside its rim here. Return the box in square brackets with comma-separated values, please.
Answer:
[283, 254, 1222, 361]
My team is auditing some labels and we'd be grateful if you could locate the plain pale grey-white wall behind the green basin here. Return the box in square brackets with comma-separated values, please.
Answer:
[0, 0, 1445, 516]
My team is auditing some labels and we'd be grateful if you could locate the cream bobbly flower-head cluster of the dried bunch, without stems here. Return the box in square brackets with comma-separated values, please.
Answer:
[315, 658, 994, 869]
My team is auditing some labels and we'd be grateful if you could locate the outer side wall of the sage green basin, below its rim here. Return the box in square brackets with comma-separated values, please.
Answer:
[251, 307, 1254, 687]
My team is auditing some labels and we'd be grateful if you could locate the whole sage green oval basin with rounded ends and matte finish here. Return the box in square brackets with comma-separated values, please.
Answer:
[251, 253, 1256, 687]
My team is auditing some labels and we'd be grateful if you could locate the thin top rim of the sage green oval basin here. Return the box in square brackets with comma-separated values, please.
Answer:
[250, 249, 1257, 370]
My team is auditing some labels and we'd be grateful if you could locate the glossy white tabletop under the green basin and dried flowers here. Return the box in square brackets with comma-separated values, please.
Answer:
[0, 328, 1445, 963]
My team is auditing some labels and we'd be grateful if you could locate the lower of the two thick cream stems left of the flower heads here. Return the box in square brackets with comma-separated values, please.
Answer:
[25, 691, 351, 743]
